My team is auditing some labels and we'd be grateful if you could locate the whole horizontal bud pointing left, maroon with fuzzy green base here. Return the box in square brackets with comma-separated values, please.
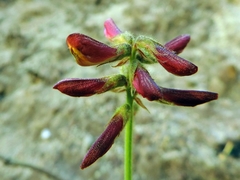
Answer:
[53, 74, 126, 97]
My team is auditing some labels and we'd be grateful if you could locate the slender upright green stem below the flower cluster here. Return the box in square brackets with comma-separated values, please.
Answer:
[124, 88, 133, 180]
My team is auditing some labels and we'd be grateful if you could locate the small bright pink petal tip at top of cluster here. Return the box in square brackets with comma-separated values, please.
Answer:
[104, 18, 122, 40]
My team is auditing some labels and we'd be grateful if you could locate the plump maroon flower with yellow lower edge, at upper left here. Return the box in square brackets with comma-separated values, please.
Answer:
[66, 33, 131, 66]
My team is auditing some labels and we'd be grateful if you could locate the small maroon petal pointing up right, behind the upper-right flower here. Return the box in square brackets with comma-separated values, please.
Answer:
[164, 34, 190, 54]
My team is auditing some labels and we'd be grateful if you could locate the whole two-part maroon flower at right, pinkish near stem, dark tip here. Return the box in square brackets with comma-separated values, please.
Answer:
[133, 65, 218, 106]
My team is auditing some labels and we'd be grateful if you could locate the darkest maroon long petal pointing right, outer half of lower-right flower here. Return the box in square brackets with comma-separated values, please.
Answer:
[159, 88, 218, 106]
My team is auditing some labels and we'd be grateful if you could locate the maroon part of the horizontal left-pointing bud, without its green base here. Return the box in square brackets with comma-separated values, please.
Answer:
[53, 78, 107, 97]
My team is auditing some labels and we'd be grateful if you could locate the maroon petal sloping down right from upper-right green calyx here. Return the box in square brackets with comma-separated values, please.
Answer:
[155, 45, 198, 76]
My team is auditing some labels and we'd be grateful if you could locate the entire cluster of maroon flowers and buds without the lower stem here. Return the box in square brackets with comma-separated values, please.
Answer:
[54, 19, 218, 169]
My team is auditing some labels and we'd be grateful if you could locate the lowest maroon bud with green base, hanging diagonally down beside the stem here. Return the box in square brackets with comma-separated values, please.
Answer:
[80, 104, 130, 169]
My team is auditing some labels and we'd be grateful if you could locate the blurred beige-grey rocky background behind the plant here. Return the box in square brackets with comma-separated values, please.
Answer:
[0, 0, 240, 180]
